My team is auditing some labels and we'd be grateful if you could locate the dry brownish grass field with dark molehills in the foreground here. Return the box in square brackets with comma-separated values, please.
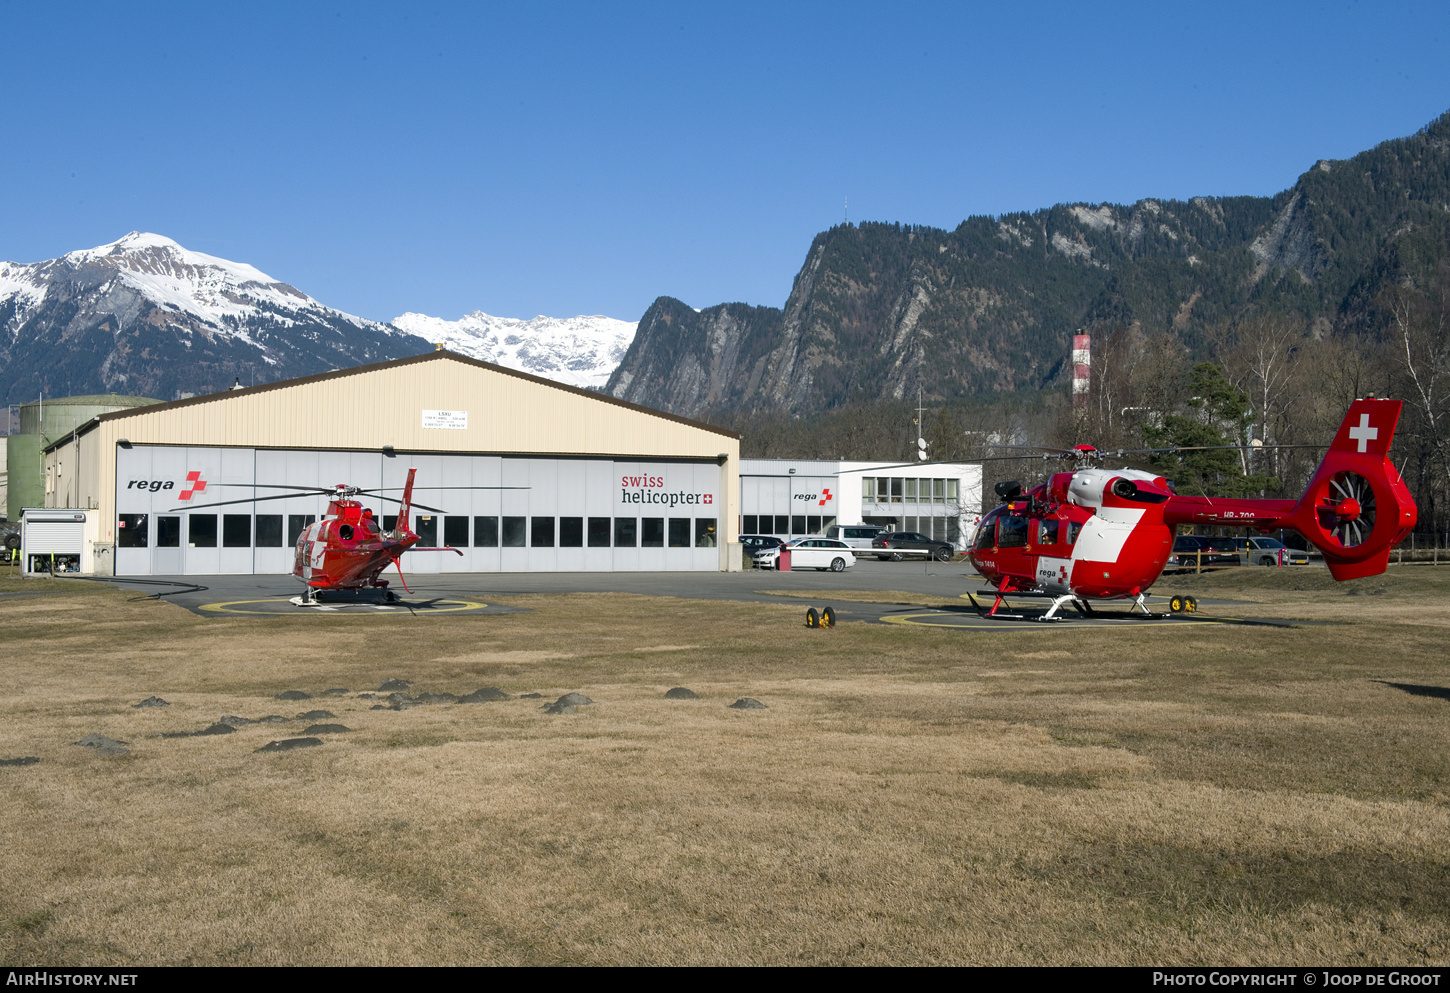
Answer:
[0, 567, 1450, 965]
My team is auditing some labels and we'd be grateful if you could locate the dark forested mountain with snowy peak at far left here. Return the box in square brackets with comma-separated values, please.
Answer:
[0, 232, 432, 403]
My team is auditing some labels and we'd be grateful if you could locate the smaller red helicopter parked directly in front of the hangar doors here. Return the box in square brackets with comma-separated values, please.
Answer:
[171, 468, 528, 606]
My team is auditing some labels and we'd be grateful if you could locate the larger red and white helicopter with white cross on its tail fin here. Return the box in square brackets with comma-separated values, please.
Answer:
[967, 397, 1418, 620]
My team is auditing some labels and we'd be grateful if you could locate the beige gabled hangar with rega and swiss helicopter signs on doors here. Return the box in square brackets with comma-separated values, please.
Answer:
[44, 349, 741, 576]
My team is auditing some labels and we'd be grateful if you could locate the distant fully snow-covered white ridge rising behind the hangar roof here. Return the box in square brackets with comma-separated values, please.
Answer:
[393, 310, 637, 390]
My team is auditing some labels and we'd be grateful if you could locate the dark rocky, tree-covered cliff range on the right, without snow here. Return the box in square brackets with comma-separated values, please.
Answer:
[605, 115, 1450, 415]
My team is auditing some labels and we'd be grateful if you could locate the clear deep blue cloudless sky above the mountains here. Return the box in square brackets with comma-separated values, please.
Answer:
[0, 1, 1450, 320]
